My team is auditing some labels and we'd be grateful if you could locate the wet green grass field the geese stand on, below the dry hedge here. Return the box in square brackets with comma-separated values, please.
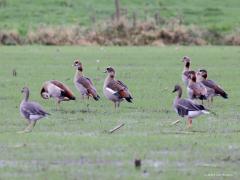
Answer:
[0, 46, 240, 180]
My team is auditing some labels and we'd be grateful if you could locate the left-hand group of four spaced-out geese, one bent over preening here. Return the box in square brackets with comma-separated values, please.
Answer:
[19, 60, 133, 133]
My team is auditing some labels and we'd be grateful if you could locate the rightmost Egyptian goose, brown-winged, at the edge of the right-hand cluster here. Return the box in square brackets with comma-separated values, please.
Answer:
[197, 69, 228, 102]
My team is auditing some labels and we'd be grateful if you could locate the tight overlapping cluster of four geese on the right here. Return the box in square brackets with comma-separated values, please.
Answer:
[173, 56, 228, 128]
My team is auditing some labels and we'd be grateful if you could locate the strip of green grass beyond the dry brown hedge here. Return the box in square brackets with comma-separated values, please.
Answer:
[0, 0, 240, 34]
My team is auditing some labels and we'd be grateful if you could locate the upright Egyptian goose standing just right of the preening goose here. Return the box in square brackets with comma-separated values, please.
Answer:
[73, 60, 100, 101]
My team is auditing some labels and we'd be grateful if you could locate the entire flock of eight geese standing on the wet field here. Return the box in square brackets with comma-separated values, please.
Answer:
[20, 56, 228, 133]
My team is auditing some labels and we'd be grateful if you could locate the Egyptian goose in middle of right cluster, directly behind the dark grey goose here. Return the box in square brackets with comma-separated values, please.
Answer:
[187, 71, 207, 100]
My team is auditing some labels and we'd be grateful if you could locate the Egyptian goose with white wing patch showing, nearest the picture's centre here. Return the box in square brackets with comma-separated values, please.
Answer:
[103, 67, 133, 108]
